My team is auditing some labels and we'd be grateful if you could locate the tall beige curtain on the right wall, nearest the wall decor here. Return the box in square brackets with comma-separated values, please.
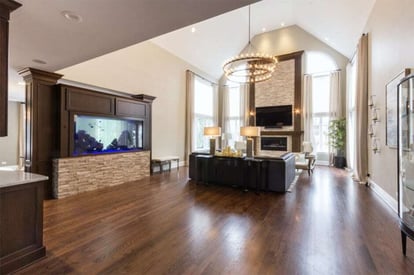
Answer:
[354, 34, 368, 183]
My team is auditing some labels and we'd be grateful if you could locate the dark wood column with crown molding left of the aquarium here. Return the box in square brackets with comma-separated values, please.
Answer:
[19, 68, 62, 199]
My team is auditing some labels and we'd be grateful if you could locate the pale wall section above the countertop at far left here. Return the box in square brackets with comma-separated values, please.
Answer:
[0, 101, 20, 166]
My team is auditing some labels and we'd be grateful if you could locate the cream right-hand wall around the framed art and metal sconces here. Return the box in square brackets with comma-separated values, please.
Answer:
[365, 0, 414, 199]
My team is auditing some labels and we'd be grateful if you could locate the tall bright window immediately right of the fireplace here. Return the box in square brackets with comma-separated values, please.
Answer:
[312, 75, 330, 157]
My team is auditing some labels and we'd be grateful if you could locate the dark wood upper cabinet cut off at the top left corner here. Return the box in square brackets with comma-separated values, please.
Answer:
[0, 0, 21, 137]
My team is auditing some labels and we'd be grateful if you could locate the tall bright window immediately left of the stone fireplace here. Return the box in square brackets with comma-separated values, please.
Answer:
[223, 86, 244, 147]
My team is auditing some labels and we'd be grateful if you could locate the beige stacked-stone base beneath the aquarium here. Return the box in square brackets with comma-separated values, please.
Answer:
[53, 151, 150, 198]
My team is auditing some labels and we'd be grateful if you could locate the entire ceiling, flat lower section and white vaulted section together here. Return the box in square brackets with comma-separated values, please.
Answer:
[9, 0, 375, 99]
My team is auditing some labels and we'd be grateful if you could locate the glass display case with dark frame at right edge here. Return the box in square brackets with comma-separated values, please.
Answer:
[398, 75, 414, 255]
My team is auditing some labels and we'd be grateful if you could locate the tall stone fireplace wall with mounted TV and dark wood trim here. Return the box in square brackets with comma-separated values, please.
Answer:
[254, 51, 303, 155]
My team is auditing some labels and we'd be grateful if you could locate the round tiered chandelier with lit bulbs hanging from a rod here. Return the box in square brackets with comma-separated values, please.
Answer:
[223, 5, 277, 83]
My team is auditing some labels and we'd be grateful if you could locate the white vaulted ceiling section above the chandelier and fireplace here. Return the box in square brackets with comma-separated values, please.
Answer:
[151, 0, 375, 79]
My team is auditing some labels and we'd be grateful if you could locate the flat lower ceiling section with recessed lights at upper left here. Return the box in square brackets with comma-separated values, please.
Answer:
[9, 0, 258, 99]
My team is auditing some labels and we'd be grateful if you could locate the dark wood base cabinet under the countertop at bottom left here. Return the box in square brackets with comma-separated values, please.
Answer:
[0, 177, 46, 274]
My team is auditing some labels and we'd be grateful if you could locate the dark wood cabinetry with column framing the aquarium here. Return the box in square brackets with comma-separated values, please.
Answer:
[19, 68, 155, 199]
